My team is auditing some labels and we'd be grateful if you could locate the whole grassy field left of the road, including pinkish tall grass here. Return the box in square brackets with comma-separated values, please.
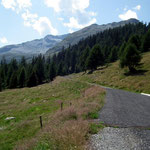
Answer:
[0, 77, 105, 150]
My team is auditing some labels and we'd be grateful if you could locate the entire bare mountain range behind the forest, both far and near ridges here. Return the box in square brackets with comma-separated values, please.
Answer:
[0, 19, 139, 61]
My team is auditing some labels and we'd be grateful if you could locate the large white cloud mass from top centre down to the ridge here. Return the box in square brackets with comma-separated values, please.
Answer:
[44, 0, 97, 32]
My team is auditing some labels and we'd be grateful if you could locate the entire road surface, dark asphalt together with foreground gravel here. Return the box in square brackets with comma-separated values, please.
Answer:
[88, 88, 150, 150]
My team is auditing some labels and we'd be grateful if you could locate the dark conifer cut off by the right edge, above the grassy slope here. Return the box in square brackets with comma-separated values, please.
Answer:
[142, 29, 150, 52]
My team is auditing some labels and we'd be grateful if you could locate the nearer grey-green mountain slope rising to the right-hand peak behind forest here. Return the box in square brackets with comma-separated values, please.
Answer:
[46, 19, 139, 55]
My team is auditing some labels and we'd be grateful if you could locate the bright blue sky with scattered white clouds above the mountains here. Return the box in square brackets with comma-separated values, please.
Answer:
[0, 0, 150, 47]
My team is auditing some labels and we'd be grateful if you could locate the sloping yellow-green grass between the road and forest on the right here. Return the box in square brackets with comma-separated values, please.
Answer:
[74, 52, 150, 94]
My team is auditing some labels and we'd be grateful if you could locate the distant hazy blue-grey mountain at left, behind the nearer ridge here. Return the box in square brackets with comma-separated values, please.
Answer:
[0, 34, 68, 60]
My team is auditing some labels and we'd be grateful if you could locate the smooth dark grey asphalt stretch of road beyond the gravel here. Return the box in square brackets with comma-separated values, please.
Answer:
[99, 89, 150, 127]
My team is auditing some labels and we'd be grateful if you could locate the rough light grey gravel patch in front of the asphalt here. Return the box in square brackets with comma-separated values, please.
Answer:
[89, 127, 150, 150]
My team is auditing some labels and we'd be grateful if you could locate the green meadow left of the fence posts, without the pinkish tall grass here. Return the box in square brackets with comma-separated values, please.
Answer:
[0, 79, 89, 150]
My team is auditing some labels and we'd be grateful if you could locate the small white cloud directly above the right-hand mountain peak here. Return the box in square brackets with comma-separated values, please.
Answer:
[119, 10, 138, 20]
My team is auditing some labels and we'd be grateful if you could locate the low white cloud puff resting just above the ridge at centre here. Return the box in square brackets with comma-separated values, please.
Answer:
[64, 17, 96, 31]
